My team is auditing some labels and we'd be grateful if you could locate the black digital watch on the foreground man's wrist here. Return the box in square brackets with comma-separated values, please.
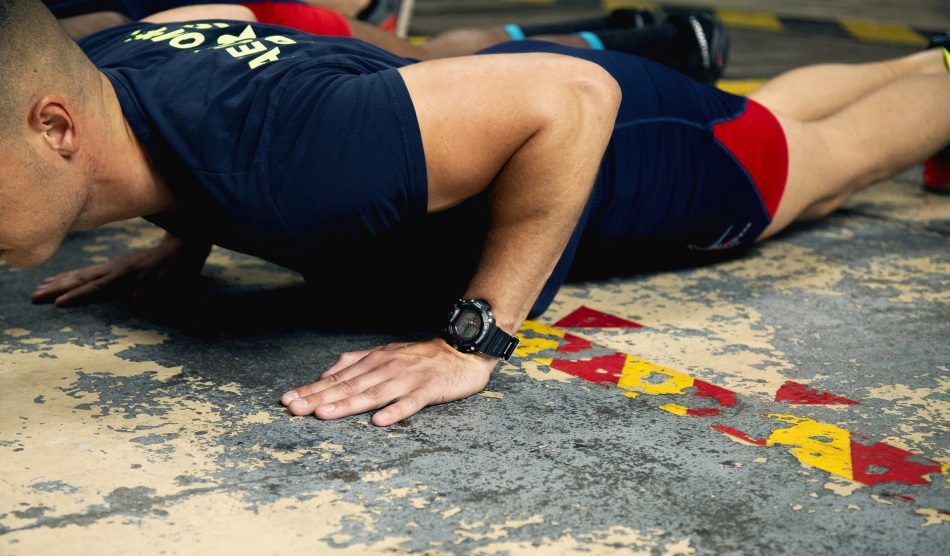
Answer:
[445, 299, 519, 361]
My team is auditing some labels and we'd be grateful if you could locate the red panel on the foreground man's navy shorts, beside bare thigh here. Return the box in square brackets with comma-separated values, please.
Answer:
[713, 99, 788, 217]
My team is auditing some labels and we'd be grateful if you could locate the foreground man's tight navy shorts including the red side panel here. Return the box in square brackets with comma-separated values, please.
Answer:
[483, 41, 788, 315]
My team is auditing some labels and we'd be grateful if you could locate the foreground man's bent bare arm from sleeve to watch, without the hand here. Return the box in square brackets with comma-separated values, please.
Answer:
[400, 54, 620, 332]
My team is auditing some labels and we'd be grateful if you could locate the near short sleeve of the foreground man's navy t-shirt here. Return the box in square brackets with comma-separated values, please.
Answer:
[267, 66, 428, 246]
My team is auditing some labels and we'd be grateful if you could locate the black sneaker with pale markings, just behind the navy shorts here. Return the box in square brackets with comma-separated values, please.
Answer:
[670, 12, 730, 85]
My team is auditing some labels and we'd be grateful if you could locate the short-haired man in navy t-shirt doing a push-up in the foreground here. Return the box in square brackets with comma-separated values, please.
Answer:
[0, 0, 950, 425]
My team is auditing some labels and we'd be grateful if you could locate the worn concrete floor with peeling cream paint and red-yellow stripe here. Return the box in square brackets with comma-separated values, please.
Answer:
[0, 0, 950, 555]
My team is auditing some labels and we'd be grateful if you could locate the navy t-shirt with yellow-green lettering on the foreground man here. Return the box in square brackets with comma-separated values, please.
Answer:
[80, 21, 498, 322]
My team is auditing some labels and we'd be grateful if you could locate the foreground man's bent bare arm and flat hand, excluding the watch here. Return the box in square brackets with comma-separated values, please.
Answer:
[281, 54, 620, 425]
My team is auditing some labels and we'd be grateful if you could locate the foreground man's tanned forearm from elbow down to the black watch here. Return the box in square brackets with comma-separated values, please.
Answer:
[465, 66, 619, 333]
